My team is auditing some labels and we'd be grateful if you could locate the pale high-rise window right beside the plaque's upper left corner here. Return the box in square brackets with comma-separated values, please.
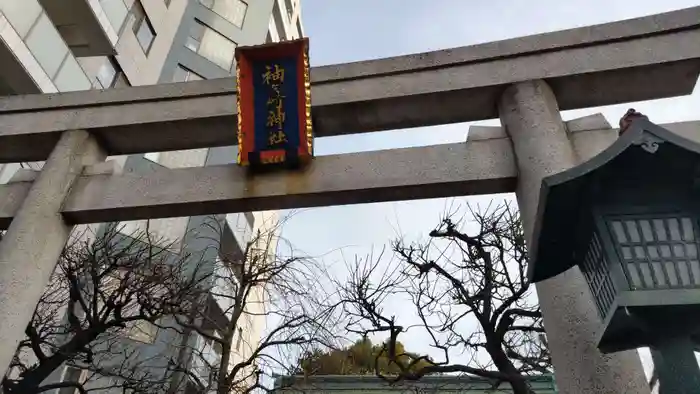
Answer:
[185, 20, 237, 72]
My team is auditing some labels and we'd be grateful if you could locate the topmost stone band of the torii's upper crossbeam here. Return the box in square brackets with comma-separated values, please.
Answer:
[0, 7, 700, 111]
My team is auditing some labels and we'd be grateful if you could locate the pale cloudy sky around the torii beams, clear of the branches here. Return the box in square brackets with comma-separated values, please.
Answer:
[276, 0, 700, 382]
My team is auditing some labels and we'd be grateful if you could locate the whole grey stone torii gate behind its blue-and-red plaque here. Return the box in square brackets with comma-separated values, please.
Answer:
[0, 7, 700, 394]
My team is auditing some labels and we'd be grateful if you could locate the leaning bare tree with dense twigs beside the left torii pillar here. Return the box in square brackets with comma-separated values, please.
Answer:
[2, 225, 211, 394]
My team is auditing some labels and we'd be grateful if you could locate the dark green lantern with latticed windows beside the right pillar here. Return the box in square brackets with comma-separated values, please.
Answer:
[528, 111, 700, 394]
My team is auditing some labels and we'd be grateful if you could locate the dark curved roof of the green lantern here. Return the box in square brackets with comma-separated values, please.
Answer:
[528, 111, 700, 282]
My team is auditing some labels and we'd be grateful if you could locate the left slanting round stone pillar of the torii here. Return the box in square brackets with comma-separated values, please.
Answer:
[0, 130, 105, 380]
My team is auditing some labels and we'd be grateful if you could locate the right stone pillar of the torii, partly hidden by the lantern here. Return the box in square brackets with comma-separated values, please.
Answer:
[499, 81, 649, 394]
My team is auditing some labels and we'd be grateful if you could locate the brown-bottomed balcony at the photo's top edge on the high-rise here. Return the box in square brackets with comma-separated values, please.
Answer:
[39, 0, 117, 57]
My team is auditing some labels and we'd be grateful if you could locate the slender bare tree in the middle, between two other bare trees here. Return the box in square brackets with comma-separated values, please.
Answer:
[171, 215, 342, 394]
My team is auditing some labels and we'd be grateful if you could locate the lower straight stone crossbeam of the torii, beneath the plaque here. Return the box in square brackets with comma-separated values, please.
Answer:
[0, 138, 516, 228]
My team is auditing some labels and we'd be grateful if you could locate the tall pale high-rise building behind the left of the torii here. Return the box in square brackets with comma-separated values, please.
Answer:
[0, 0, 303, 394]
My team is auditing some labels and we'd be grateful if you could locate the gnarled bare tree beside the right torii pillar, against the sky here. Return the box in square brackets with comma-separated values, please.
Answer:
[341, 204, 551, 394]
